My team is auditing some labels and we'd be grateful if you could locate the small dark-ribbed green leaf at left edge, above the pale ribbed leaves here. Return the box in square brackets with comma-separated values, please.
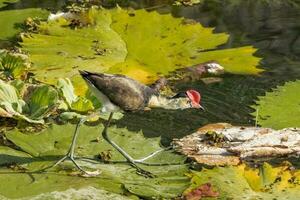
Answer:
[0, 50, 30, 78]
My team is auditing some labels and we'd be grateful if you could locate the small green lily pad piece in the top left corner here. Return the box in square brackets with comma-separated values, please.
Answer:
[0, 8, 49, 40]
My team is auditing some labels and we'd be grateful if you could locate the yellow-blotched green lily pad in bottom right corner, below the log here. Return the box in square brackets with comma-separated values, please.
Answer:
[185, 163, 300, 199]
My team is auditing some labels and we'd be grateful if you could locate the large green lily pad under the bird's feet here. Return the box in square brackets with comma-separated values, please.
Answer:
[0, 124, 189, 199]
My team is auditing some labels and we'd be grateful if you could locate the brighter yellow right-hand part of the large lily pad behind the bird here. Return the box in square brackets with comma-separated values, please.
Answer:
[110, 9, 261, 82]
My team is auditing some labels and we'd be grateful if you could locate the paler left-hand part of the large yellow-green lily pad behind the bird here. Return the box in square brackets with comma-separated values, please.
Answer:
[21, 10, 127, 94]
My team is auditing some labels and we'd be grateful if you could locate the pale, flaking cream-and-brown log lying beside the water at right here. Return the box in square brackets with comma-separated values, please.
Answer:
[173, 123, 300, 165]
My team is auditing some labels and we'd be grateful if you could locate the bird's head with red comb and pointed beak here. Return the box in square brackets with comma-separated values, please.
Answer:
[172, 90, 204, 110]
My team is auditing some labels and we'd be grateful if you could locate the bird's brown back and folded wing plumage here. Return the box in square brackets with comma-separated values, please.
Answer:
[79, 71, 157, 111]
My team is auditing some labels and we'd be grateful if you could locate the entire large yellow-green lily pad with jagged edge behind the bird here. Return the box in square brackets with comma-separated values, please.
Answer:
[20, 8, 261, 94]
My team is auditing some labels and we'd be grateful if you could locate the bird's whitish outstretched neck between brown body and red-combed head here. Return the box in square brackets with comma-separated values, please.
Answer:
[148, 95, 187, 109]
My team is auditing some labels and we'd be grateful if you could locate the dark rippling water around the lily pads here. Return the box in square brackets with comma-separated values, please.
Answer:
[2, 0, 300, 144]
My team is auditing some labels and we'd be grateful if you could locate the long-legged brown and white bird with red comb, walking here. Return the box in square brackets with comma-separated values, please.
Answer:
[54, 70, 204, 176]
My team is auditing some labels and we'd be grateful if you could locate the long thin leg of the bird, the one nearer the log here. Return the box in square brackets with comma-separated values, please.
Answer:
[102, 112, 154, 177]
